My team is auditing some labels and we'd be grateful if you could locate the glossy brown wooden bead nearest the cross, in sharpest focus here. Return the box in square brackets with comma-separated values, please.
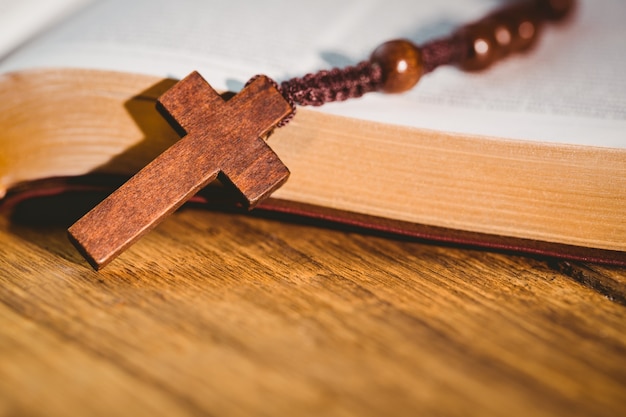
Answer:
[370, 39, 423, 93]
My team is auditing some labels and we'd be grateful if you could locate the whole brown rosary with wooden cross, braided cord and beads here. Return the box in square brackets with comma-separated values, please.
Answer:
[68, 0, 575, 269]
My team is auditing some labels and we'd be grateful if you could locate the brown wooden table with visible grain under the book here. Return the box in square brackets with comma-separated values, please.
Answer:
[0, 196, 626, 416]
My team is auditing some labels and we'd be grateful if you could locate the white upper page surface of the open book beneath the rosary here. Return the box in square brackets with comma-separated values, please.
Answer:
[0, 0, 626, 148]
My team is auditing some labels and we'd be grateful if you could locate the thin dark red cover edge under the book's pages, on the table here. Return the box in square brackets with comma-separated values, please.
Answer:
[6, 175, 626, 266]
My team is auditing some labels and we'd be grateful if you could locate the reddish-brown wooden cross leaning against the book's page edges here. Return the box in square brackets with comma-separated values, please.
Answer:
[68, 72, 292, 269]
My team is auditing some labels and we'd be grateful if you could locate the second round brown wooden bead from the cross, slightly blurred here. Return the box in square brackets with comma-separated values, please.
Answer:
[459, 20, 500, 71]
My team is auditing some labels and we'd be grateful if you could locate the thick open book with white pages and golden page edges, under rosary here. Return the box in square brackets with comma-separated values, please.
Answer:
[0, 0, 626, 264]
